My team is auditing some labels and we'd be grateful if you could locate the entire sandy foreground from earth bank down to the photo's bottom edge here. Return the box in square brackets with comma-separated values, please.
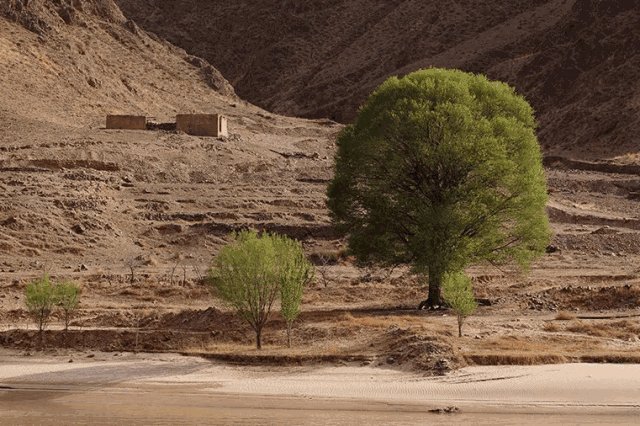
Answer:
[0, 353, 640, 424]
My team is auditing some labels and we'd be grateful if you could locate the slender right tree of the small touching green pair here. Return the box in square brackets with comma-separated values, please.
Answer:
[274, 237, 314, 347]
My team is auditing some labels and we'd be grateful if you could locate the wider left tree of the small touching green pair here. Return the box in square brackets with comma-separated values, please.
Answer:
[209, 231, 280, 349]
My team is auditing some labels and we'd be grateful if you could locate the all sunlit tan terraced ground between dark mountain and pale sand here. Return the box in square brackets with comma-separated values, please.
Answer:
[0, 0, 640, 372]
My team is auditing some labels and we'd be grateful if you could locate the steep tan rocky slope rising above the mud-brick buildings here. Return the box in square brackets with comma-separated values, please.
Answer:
[0, 0, 238, 126]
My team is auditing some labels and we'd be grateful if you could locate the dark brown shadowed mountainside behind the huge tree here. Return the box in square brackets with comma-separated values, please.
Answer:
[117, 0, 640, 161]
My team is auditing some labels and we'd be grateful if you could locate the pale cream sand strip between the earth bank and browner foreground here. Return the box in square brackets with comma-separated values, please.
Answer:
[0, 354, 640, 413]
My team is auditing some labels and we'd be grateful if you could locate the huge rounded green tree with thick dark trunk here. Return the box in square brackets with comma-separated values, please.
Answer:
[328, 68, 550, 307]
